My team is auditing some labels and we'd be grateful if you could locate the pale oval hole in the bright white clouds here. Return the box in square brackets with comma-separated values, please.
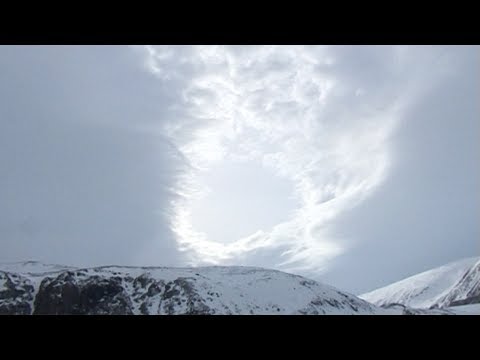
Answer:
[190, 162, 298, 244]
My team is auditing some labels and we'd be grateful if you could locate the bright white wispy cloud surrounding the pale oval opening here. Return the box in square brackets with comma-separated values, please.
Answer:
[139, 46, 430, 271]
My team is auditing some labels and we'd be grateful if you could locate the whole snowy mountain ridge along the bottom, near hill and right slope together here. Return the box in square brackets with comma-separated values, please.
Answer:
[0, 258, 480, 315]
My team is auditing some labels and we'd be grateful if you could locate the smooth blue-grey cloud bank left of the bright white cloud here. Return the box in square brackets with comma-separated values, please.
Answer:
[0, 46, 188, 266]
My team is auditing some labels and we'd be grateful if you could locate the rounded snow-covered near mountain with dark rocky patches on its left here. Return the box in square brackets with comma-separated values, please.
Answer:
[0, 262, 384, 314]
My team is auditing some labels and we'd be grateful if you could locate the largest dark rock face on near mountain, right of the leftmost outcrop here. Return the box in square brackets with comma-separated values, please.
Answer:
[33, 272, 219, 315]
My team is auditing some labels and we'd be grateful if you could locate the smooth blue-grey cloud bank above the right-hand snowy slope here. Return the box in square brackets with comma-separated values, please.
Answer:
[322, 46, 480, 293]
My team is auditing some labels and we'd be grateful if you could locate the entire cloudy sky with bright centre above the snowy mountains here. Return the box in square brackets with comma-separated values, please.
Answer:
[0, 45, 480, 294]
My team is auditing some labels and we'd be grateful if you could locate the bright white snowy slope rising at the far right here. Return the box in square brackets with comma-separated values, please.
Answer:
[360, 257, 480, 309]
